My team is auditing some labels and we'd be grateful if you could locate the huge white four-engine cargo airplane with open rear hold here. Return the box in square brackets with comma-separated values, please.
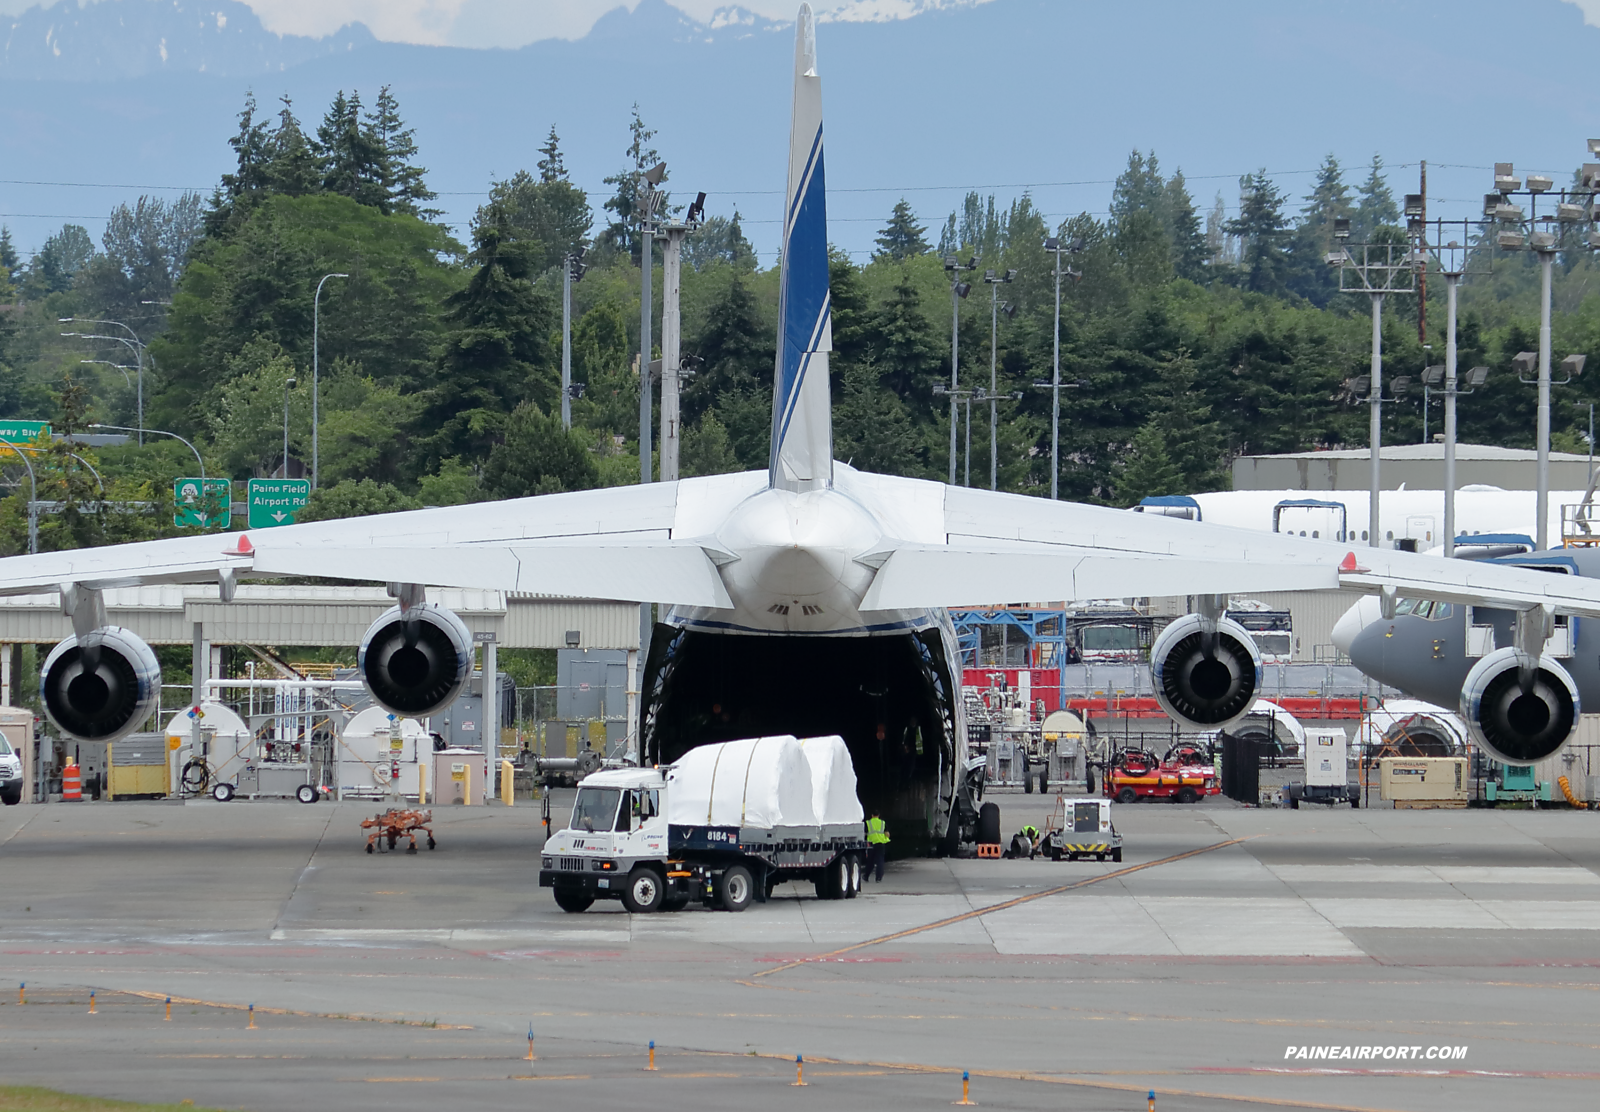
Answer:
[12, 6, 1600, 851]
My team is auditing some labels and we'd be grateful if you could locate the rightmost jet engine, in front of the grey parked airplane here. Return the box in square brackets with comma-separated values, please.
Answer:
[1461, 648, 1581, 765]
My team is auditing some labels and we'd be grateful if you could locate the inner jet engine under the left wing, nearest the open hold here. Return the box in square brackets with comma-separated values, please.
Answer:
[355, 603, 472, 718]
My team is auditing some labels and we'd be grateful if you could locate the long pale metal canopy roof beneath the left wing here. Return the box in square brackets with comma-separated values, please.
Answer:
[0, 584, 638, 650]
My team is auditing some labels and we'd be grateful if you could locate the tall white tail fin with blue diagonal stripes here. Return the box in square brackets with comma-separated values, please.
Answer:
[768, 3, 834, 490]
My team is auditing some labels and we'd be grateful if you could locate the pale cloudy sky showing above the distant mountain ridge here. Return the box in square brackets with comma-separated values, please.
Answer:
[0, 0, 985, 46]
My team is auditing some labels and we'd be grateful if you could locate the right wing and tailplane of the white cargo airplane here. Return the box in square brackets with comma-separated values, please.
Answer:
[862, 483, 1600, 618]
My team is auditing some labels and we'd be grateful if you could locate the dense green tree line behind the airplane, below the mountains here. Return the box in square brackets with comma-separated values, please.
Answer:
[0, 88, 1600, 552]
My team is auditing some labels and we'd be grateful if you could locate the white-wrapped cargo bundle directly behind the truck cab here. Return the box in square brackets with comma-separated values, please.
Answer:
[667, 734, 819, 830]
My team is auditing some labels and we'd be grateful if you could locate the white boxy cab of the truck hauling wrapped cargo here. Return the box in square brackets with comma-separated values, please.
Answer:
[539, 768, 668, 910]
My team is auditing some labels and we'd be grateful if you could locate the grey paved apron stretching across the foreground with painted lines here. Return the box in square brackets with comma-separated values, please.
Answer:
[0, 795, 1600, 1112]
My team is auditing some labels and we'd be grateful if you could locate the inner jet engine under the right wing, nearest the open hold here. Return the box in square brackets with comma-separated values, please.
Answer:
[1150, 614, 1261, 730]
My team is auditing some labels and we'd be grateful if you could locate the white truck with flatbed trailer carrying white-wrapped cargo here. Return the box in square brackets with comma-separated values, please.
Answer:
[539, 736, 867, 912]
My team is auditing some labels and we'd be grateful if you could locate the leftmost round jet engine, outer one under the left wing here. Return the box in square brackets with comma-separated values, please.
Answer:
[38, 626, 162, 741]
